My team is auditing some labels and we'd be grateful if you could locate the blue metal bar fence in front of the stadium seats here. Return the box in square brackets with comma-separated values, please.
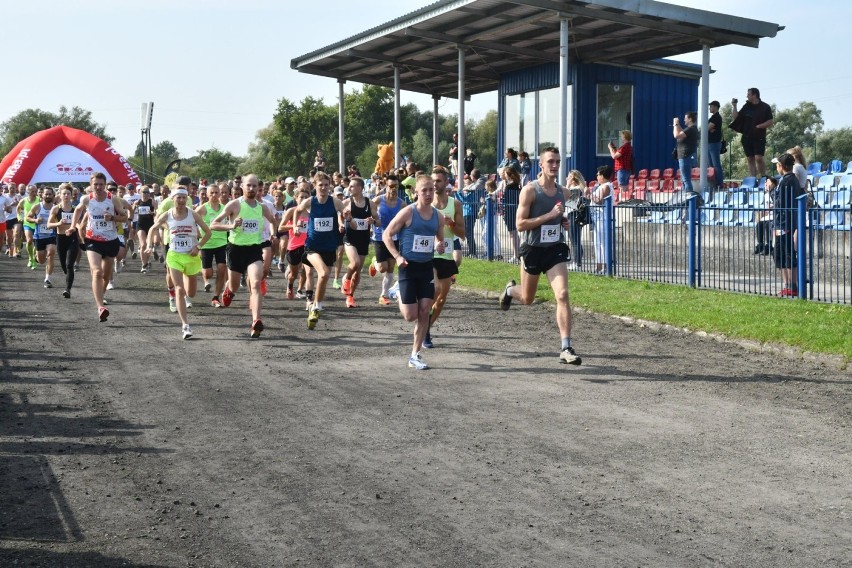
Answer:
[472, 190, 852, 304]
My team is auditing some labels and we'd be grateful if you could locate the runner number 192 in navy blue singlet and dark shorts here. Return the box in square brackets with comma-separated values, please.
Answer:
[294, 172, 349, 329]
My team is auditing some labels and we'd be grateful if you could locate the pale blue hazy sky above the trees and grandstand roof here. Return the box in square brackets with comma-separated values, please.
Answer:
[5, 0, 852, 161]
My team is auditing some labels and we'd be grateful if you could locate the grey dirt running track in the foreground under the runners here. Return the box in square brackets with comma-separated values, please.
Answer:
[0, 257, 852, 567]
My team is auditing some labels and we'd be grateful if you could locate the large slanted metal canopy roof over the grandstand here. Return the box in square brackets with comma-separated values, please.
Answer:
[290, 0, 784, 97]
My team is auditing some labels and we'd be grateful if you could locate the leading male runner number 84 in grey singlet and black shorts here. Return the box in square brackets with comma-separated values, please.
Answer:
[500, 147, 582, 365]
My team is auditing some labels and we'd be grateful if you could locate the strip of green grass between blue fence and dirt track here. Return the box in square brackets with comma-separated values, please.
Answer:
[458, 258, 852, 360]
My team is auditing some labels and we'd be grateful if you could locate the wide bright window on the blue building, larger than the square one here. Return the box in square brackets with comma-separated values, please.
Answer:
[501, 86, 572, 161]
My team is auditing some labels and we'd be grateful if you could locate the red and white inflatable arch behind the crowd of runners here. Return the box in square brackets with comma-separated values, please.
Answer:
[0, 126, 139, 185]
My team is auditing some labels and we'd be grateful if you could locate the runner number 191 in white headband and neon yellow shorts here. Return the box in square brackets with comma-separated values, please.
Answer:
[146, 189, 210, 339]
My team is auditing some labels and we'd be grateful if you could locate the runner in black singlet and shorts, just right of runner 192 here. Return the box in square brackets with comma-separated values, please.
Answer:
[341, 177, 378, 308]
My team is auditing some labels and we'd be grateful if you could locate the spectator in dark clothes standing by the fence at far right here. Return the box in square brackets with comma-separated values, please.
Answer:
[772, 154, 803, 298]
